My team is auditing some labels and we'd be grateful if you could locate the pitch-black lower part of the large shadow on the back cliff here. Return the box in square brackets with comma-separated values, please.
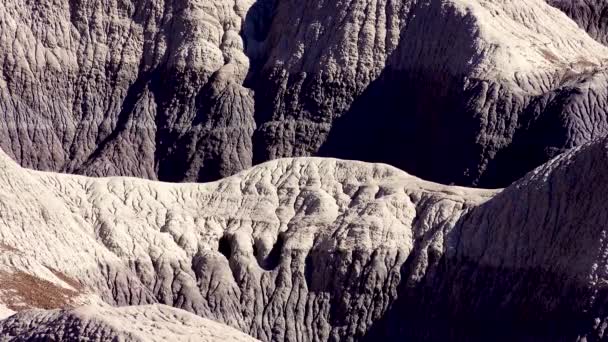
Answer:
[319, 69, 482, 185]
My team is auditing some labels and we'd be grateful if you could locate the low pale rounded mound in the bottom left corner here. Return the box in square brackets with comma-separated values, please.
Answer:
[0, 305, 257, 342]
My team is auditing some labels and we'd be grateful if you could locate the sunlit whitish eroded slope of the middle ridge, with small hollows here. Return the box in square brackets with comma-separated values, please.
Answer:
[0, 146, 494, 340]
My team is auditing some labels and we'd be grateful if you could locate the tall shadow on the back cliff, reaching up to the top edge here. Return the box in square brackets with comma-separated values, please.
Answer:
[319, 1, 483, 185]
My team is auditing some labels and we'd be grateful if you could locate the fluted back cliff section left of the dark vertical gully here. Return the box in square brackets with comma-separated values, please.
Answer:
[0, 0, 254, 180]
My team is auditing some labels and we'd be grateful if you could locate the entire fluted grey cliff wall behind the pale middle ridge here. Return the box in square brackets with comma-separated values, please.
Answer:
[0, 0, 608, 186]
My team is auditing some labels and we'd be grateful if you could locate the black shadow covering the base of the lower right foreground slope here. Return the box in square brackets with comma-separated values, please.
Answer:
[360, 206, 596, 342]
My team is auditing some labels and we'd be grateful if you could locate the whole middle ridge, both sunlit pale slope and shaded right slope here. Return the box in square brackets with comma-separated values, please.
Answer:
[0, 135, 608, 341]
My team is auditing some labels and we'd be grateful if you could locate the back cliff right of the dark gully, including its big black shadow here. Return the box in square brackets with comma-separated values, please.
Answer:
[262, 1, 607, 187]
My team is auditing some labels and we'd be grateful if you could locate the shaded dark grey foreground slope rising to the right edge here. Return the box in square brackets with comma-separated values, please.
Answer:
[364, 139, 608, 341]
